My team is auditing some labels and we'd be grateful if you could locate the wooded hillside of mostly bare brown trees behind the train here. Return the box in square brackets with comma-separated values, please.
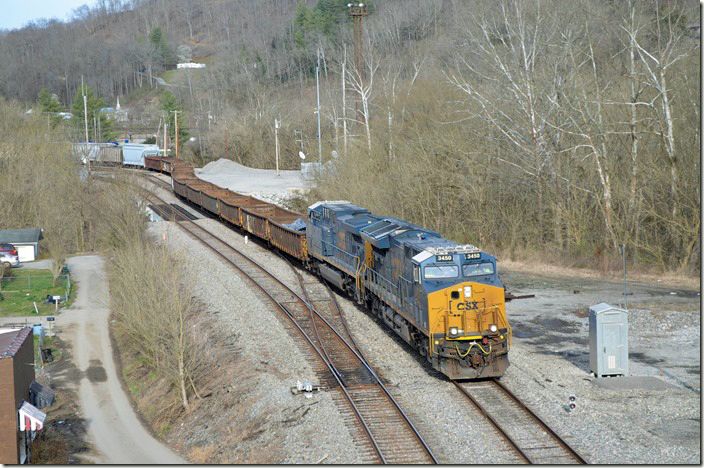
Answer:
[0, 0, 701, 272]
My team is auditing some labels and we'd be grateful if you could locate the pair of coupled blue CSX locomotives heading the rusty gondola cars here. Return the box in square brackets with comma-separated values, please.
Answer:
[306, 201, 511, 380]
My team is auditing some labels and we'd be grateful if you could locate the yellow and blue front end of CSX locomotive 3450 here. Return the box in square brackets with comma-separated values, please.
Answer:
[421, 249, 511, 380]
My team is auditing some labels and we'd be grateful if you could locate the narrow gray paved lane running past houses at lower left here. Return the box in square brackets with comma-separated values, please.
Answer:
[56, 256, 186, 465]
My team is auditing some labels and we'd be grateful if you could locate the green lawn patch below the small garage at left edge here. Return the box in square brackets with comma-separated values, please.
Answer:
[0, 270, 73, 317]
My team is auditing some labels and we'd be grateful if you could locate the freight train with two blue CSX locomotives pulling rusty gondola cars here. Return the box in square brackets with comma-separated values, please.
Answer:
[144, 156, 512, 380]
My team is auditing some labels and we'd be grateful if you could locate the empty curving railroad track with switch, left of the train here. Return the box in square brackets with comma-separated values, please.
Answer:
[141, 186, 438, 464]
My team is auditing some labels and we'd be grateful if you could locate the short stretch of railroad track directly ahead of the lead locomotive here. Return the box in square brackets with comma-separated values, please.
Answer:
[453, 379, 587, 465]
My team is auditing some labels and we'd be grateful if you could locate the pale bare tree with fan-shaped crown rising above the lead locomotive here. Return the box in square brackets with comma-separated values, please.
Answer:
[445, 1, 564, 238]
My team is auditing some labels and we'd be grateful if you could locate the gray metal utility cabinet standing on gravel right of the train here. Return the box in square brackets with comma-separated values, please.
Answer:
[589, 302, 628, 377]
